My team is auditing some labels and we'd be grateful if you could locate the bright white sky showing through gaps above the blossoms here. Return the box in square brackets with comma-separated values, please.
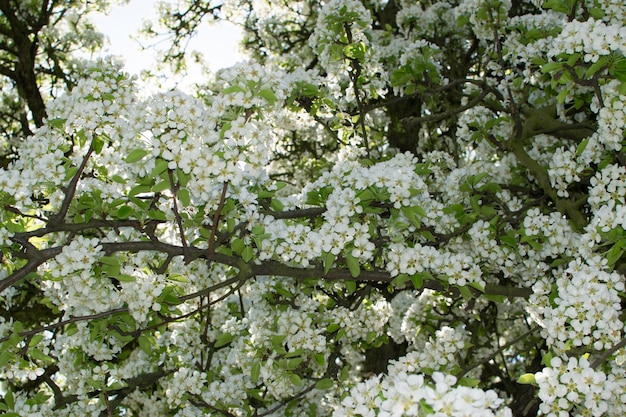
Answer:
[90, 0, 245, 86]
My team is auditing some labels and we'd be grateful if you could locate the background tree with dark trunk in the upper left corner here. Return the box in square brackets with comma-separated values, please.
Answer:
[0, 0, 117, 162]
